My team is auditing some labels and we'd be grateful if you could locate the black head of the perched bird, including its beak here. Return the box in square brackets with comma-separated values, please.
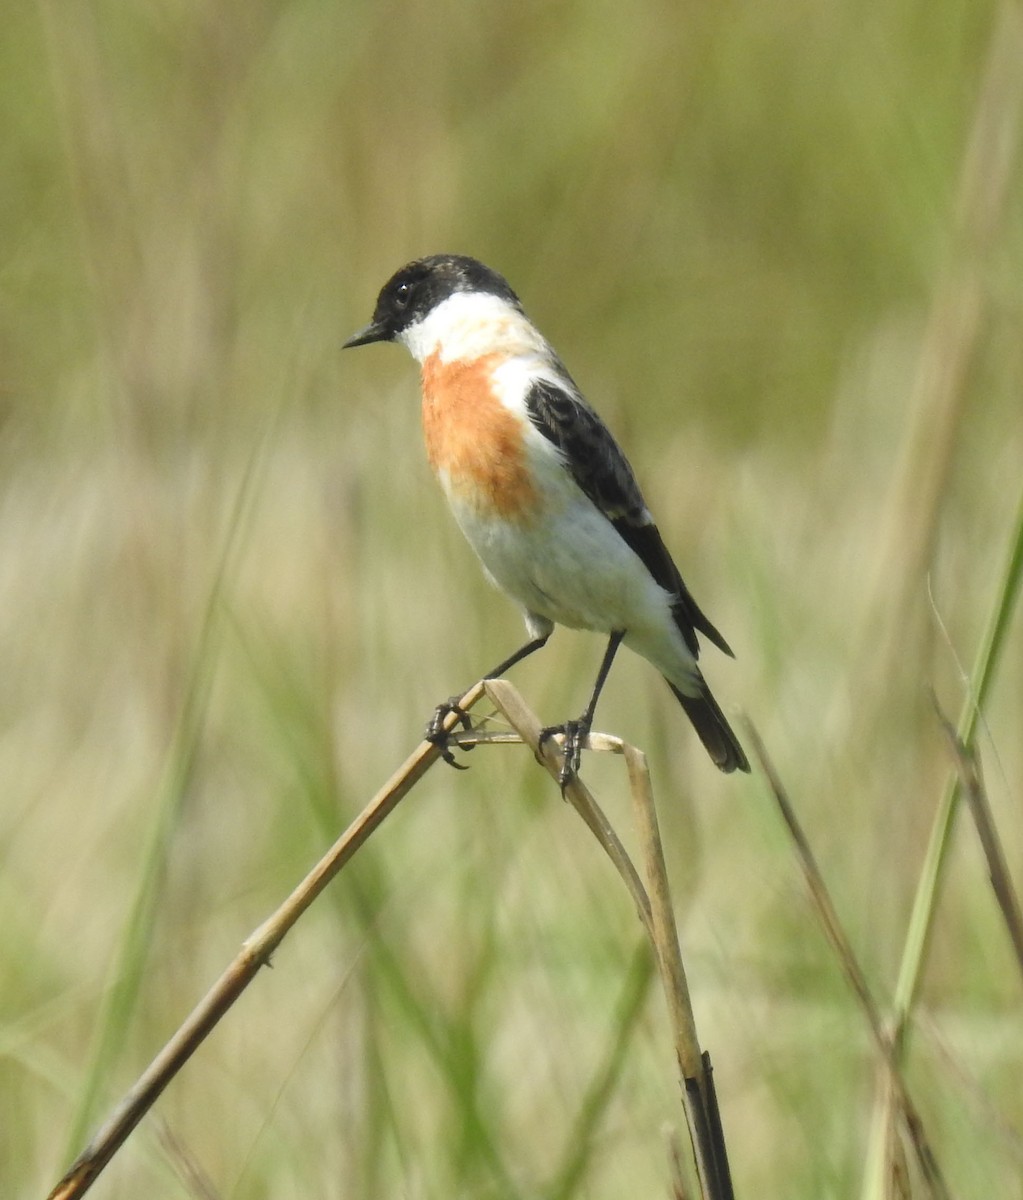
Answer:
[343, 254, 522, 349]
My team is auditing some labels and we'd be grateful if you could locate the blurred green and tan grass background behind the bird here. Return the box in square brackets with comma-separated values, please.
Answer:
[0, 0, 1023, 1198]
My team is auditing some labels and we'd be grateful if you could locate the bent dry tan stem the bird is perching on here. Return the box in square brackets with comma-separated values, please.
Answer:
[48, 680, 732, 1200]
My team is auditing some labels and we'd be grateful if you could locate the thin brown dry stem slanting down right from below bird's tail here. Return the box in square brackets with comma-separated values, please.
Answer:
[743, 718, 950, 1200]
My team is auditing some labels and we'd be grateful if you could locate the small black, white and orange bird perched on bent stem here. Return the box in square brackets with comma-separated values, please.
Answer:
[343, 254, 749, 791]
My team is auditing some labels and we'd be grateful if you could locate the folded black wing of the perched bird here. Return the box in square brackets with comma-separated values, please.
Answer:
[526, 379, 731, 655]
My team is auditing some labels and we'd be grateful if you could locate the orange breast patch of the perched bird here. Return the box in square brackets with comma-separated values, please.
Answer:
[423, 354, 537, 521]
